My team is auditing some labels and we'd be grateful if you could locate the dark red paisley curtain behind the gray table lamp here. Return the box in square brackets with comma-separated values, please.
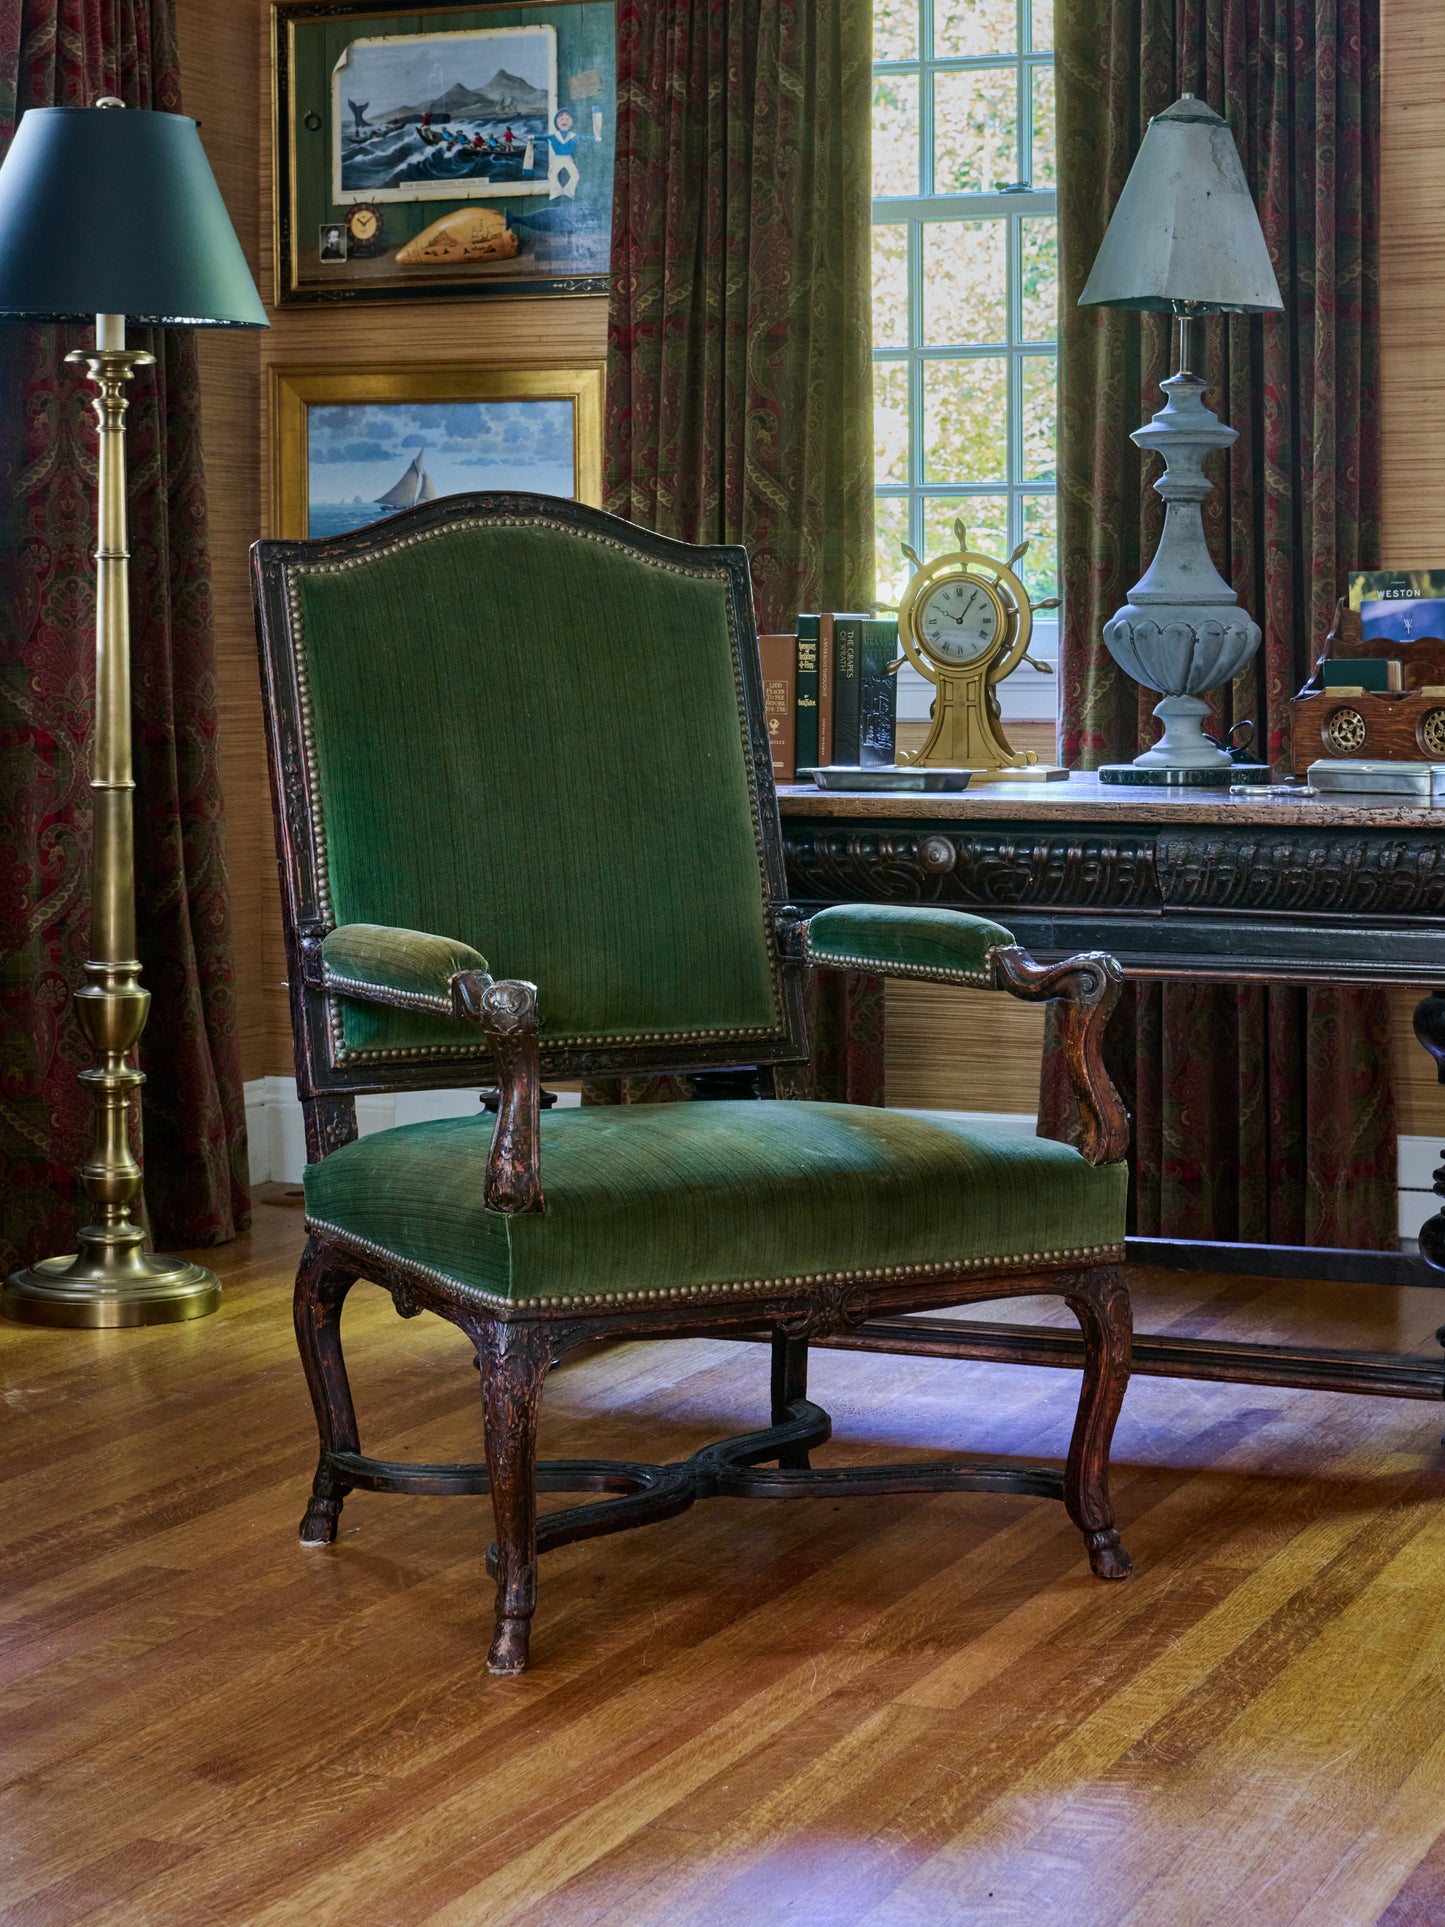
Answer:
[1040, 0, 1397, 1249]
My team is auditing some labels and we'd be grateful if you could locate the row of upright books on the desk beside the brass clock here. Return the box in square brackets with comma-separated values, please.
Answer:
[757, 613, 898, 782]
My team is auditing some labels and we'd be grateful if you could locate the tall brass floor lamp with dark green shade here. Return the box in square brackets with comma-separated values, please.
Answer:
[0, 96, 268, 1326]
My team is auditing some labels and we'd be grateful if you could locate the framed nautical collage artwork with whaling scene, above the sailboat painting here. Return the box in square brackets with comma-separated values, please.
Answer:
[272, 0, 617, 303]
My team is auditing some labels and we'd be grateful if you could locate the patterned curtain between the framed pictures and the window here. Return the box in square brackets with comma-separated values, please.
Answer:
[597, 0, 882, 1104]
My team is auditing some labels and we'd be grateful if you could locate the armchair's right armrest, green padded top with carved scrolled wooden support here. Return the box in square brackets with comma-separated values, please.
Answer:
[803, 904, 1129, 1164]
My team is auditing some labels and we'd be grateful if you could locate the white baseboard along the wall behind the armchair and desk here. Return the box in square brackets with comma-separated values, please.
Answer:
[245, 1077, 1445, 1251]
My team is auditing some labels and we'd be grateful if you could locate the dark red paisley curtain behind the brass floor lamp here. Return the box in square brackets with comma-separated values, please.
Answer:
[0, 0, 249, 1270]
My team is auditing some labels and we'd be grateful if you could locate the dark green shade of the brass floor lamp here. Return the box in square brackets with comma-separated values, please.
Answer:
[0, 108, 270, 328]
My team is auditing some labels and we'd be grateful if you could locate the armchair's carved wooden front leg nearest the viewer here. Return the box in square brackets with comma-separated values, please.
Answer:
[478, 1320, 553, 1673]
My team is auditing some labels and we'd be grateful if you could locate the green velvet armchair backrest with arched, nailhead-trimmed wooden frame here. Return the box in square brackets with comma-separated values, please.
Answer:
[252, 493, 803, 1096]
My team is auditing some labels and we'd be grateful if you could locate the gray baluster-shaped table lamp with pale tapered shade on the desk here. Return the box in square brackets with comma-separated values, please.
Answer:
[1079, 94, 1283, 784]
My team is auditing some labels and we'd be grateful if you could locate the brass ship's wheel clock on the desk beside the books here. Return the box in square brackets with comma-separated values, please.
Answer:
[898, 520, 1067, 782]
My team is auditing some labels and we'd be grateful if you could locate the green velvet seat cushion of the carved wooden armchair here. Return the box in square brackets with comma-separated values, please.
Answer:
[306, 1100, 1125, 1307]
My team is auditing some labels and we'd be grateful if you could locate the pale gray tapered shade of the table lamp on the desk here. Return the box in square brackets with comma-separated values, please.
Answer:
[1079, 94, 1283, 314]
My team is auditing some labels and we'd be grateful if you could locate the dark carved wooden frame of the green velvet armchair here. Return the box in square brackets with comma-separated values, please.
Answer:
[252, 493, 1131, 1673]
